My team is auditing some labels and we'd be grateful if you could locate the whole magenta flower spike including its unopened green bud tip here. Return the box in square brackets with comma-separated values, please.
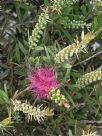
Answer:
[29, 67, 70, 108]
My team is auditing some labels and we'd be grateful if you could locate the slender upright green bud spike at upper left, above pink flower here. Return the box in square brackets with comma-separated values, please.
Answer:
[28, 8, 49, 48]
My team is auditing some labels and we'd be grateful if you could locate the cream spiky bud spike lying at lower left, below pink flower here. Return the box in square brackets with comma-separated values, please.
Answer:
[12, 100, 53, 122]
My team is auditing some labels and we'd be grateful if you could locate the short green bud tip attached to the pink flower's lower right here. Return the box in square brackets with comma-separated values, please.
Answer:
[49, 89, 70, 108]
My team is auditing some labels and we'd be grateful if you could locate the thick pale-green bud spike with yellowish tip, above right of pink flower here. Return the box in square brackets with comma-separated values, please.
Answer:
[55, 33, 95, 63]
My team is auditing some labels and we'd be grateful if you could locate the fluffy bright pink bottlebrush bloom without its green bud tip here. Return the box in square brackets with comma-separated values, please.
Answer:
[29, 67, 58, 98]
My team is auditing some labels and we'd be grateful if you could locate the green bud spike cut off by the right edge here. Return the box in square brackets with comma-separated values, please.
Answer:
[76, 71, 102, 88]
